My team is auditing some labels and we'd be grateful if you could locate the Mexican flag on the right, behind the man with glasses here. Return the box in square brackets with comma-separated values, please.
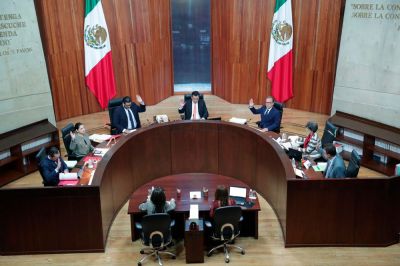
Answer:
[268, 0, 293, 102]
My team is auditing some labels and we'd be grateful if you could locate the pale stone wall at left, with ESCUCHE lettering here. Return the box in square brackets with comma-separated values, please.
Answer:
[0, 0, 55, 133]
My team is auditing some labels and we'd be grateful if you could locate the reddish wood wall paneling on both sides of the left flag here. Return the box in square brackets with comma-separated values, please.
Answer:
[35, 0, 172, 120]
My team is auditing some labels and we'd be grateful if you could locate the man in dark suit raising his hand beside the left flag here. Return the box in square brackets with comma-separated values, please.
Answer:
[112, 95, 146, 134]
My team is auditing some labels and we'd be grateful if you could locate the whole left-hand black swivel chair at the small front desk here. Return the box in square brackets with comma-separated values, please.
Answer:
[135, 213, 176, 266]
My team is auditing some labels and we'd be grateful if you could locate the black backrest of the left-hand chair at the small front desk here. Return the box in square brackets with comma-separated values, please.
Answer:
[142, 213, 171, 247]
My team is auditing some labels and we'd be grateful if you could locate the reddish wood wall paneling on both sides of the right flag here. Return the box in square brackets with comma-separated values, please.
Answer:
[212, 0, 343, 113]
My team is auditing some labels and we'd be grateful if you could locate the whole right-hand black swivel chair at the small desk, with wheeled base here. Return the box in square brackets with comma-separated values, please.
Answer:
[205, 206, 245, 263]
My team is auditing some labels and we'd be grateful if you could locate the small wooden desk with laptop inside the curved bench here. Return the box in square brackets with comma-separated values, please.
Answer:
[128, 173, 260, 241]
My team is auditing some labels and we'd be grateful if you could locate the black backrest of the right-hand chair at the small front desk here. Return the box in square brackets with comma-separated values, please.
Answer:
[213, 206, 242, 240]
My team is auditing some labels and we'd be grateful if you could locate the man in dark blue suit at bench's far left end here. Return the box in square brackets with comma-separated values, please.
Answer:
[39, 147, 68, 186]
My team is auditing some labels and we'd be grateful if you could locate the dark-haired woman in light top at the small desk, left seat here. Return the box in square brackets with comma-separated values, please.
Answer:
[139, 187, 176, 214]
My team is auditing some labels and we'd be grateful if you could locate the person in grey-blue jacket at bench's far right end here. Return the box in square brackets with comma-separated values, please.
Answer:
[324, 143, 346, 178]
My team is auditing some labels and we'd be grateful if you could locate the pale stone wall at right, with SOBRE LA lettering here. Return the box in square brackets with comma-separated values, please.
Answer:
[332, 0, 400, 127]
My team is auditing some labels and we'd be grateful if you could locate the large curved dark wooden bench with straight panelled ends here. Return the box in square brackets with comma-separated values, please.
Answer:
[0, 121, 400, 255]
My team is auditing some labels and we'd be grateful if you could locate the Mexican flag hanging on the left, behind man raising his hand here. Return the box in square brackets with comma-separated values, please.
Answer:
[84, 0, 116, 109]
